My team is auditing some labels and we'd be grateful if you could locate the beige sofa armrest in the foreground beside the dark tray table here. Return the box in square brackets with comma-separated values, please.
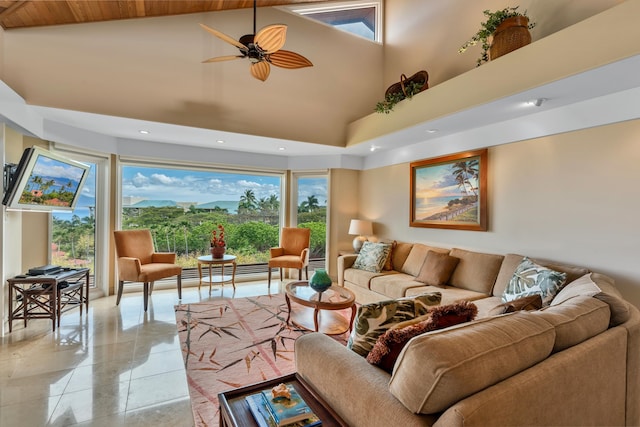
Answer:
[295, 333, 436, 427]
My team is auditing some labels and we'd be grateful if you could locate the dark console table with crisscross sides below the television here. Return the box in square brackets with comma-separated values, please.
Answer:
[7, 268, 89, 332]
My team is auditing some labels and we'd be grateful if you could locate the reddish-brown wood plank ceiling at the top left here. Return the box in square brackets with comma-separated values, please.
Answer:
[0, 0, 327, 30]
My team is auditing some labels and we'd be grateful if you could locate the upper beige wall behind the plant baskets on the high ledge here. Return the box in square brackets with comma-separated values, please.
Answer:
[383, 0, 624, 87]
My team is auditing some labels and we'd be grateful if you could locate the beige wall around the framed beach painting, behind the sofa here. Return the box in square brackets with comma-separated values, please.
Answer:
[359, 120, 640, 307]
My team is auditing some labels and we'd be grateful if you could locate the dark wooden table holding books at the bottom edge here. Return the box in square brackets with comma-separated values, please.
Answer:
[218, 374, 347, 427]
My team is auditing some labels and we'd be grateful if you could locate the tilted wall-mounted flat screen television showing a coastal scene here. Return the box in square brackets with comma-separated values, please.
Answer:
[2, 147, 90, 211]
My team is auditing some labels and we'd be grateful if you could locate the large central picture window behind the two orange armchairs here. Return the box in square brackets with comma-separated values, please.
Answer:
[121, 164, 283, 271]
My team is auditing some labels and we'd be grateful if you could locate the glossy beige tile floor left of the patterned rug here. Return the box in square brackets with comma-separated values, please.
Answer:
[0, 281, 284, 427]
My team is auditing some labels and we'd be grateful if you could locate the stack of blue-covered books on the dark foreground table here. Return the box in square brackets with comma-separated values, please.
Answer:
[245, 385, 321, 427]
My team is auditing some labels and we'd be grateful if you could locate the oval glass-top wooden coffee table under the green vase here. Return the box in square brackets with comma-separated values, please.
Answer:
[285, 280, 356, 335]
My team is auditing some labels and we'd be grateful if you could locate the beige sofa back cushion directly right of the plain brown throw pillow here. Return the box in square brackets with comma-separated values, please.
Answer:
[449, 248, 504, 295]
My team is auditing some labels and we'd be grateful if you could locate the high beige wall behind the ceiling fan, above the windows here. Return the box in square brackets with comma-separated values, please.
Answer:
[2, 8, 383, 145]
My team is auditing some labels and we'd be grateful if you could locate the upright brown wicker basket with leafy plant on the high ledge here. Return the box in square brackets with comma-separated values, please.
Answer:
[458, 6, 536, 66]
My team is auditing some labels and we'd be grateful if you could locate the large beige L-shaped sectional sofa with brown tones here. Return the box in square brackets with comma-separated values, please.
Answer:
[295, 243, 640, 426]
